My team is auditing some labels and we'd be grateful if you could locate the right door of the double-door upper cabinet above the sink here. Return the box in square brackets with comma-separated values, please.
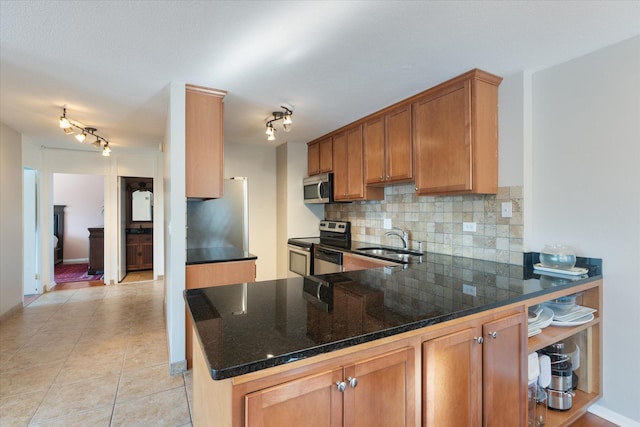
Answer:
[386, 105, 413, 182]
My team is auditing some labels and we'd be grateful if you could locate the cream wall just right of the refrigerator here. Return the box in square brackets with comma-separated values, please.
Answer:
[224, 141, 276, 281]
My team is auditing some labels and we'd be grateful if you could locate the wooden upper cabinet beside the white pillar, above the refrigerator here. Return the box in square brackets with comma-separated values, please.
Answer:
[185, 85, 227, 199]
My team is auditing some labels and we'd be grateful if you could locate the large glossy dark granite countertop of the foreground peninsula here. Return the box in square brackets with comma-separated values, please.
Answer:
[184, 253, 602, 380]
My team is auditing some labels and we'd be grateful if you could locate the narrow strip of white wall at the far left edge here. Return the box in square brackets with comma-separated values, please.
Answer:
[0, 123, 23, 316]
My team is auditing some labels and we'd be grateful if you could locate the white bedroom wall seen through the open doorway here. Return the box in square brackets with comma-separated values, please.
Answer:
[53, 173, 104, 262]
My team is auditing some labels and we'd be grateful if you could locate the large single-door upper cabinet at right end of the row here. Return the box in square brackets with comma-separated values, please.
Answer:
[412, 69, 502, 195]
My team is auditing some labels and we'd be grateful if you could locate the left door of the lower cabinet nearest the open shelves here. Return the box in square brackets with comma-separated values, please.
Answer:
[422, 327, 482, 427]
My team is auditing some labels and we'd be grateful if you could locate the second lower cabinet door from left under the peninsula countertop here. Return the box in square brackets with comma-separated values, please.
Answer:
[344, 348, 415, 427]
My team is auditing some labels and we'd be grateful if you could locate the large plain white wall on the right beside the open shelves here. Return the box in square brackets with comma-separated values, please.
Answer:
[531, 37, 640, 422]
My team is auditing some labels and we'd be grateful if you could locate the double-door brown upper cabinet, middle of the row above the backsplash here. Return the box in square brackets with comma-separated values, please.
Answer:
[364, 104, 413, 185]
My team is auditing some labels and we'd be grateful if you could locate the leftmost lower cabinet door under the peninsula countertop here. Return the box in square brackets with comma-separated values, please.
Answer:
[245, 368, 344, 427]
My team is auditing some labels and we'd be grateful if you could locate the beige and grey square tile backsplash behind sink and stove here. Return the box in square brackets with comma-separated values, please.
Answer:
[325, 184, 524, 265]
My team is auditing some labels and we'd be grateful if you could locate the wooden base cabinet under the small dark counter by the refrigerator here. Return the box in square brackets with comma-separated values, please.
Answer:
[185, 259, 256, 369]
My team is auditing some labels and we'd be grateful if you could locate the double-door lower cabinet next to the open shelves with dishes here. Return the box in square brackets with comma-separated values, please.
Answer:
[422, 313, 527, 427]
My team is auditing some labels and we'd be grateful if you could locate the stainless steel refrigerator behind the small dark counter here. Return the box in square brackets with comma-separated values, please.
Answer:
[187, 177, 249, 252]
